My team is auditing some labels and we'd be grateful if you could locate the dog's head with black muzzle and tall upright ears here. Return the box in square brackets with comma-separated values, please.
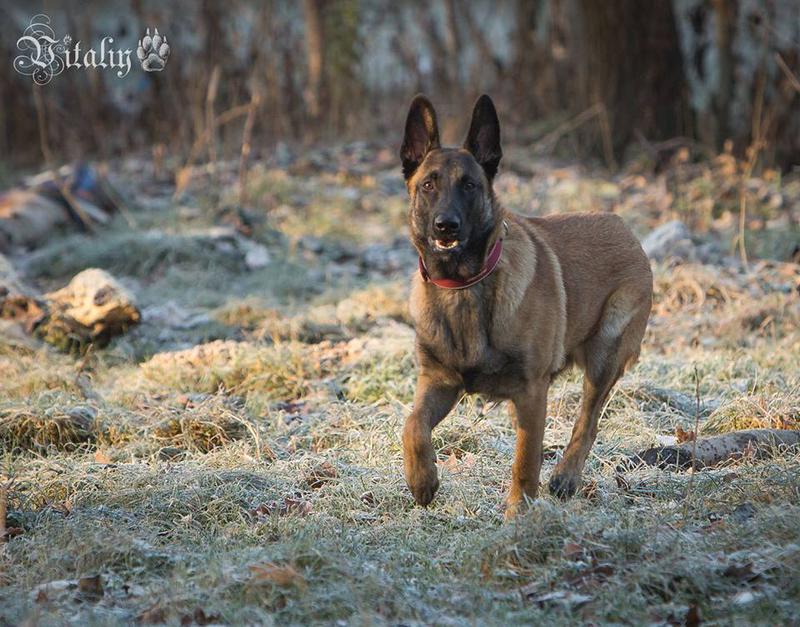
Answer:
[400, 96, 502, 279]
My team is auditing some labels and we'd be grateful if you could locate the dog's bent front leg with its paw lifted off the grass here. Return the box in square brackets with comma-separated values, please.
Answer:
[403, 373, 461, 505]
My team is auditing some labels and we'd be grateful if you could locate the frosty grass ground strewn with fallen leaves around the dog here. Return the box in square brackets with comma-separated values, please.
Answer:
[0, 145, 800, 625]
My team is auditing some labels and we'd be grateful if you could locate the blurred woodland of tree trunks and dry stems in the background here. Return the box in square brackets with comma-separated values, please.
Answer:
[0, 0, 800, 169]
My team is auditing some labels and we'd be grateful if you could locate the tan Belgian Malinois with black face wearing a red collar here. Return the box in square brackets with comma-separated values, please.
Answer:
[400, 95, 653, 515]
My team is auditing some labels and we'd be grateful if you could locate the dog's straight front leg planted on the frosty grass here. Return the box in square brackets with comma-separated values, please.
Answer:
[506, 379, 550, 518]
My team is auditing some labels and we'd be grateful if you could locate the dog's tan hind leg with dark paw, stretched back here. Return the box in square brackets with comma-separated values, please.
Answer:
[548, 286, 650, 498]
